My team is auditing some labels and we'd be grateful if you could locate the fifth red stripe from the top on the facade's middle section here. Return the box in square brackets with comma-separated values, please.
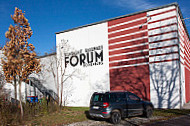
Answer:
[109, 38, 148, 50]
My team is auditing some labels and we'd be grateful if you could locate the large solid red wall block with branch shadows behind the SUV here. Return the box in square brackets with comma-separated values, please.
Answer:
[109, 65, 150, 100]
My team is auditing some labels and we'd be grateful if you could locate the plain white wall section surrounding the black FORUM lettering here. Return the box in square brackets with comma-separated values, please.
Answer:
[56, 23, 110, 106]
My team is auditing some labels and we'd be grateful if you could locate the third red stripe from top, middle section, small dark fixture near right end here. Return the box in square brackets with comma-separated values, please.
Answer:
[108, 25, 147, 38]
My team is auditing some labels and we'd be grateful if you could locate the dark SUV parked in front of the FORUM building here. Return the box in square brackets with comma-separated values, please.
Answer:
[89, 91, 154, 124]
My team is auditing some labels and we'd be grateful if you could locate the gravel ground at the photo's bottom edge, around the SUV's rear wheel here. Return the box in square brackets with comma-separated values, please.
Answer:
[64, 116, 163, 126]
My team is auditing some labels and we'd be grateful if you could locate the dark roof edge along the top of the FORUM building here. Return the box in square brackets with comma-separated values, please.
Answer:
[55, 2, 180, 34]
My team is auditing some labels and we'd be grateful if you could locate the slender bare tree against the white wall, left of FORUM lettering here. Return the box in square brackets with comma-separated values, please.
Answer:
[47, 40, 78, 106]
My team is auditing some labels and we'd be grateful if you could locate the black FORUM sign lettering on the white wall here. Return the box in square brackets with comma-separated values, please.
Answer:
[65, 45, 103, 67]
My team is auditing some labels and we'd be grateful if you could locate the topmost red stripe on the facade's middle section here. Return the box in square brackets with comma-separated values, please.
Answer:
[108, 13, 146, 26]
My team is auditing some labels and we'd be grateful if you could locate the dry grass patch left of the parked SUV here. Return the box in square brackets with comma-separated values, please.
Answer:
[24, 107, 89, 126]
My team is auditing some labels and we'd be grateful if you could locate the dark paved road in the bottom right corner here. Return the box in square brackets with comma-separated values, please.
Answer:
[144, 115, 190, 126]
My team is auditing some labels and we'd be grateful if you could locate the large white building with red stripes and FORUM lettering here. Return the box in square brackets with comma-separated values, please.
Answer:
[0, 3, 190, 108]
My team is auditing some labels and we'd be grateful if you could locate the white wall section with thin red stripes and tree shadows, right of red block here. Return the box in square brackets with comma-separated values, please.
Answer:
[147, 6, 180, 108]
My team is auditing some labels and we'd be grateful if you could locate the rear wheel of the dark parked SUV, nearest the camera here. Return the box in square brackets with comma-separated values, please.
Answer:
[110, 110, 121, 124]
